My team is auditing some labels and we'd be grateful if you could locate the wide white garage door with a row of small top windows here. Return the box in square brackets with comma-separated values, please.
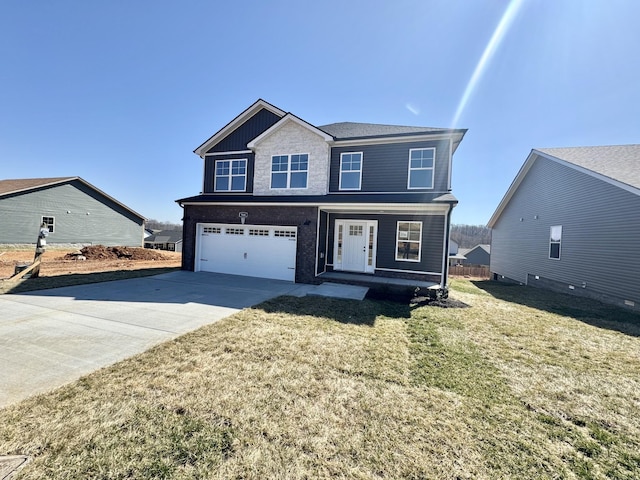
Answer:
[196, 223, 297, 282]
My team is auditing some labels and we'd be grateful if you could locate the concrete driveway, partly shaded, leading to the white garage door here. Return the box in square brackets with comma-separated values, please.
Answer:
[0, 271, 314, 408]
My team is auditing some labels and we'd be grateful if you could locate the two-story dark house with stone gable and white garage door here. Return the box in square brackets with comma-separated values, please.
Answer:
[178, 100, 466, 292]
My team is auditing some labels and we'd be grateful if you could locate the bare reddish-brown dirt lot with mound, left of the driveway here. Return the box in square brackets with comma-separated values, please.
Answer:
[0, 246, 182, 279]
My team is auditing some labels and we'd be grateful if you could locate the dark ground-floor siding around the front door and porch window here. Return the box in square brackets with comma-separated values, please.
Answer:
[327, 214, 445, 273]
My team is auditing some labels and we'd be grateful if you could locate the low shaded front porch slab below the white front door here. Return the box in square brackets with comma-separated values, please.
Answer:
[317, 271, 448, 298]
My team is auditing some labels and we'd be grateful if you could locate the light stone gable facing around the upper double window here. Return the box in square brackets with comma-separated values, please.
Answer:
[253, 122, 330, 195]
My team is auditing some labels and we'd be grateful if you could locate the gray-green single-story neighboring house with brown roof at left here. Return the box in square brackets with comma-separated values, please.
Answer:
[0, 177, 145, 247]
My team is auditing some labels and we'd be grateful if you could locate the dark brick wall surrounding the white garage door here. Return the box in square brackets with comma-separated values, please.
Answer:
[182, 205, 319, 283]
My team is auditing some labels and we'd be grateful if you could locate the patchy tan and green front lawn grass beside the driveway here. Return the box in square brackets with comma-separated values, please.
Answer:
[0, 281, 640, 479]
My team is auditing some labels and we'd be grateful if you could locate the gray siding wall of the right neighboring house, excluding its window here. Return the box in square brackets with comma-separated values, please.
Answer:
[490, 157, 640, 305]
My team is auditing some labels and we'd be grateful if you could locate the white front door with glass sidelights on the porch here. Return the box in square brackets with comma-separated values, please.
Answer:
[333, 220, 378, 273]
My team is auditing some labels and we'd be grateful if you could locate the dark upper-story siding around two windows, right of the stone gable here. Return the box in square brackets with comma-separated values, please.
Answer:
[329, 140, 449, 194]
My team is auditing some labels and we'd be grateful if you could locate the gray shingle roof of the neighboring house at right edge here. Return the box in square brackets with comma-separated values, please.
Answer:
[536, 145, 640, 188]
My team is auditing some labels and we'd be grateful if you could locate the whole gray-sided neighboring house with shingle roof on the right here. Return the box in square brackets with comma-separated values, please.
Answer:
[488, 145, 640, 308]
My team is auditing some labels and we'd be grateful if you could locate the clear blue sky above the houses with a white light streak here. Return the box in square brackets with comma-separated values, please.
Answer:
[0, 0, 640, 224]
